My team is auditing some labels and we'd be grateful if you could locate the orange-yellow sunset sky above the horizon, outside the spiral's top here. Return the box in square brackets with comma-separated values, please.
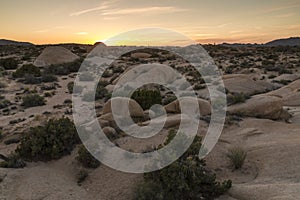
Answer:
[0, 0, 300, 44]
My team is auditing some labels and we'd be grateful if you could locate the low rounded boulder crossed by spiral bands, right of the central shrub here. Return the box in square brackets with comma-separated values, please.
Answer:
[164, 97, 211, 116]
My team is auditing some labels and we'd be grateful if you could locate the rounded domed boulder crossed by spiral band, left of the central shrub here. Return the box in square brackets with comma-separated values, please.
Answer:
[102, 97, 144, 117]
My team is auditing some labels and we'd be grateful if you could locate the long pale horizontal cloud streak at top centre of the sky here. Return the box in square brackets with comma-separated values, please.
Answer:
[102, 6, 186, 15]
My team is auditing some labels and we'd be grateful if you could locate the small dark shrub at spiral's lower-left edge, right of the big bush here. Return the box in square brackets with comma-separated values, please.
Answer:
[76, 144, 100, 168]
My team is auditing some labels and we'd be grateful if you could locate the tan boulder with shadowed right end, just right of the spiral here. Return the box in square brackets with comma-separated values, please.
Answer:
[227, 95, 288, 119]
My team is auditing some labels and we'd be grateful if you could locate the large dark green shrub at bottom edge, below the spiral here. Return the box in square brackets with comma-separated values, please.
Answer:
[134, 131, 231, 200]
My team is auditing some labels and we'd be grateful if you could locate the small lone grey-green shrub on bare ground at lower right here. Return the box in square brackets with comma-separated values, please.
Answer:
[227, 147, 247, 169]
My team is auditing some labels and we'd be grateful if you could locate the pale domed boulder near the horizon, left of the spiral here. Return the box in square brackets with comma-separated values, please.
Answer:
[33, 46, 79, 67]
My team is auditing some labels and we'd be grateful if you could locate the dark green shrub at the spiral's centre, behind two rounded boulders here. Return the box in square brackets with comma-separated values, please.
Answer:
[131, 89, 162, 110]
